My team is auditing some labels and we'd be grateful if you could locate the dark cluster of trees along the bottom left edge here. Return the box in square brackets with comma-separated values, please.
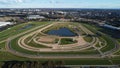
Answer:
[2, 61, 65, 68]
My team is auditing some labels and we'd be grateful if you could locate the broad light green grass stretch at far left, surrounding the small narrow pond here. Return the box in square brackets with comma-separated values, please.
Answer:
[0, 22, 48, 41]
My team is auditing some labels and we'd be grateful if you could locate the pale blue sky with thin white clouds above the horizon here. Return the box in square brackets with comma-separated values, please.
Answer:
[0, 0, 120, 9]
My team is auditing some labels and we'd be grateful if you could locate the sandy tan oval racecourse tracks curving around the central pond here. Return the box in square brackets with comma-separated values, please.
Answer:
[2, 22, 117, 58]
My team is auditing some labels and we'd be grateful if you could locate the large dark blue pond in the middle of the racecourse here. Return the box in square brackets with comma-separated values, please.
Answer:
[47, 28, 77, 36]
